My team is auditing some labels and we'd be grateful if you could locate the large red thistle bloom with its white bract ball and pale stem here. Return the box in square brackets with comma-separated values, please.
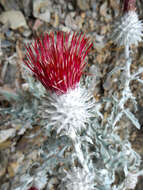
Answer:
[25, 32, 98, 176]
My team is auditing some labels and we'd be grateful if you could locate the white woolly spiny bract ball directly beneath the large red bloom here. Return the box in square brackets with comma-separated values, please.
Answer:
[42, 87, 95, 135]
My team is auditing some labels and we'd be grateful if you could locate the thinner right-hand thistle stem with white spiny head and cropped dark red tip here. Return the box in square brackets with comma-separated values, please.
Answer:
[112, 0, 143, 129]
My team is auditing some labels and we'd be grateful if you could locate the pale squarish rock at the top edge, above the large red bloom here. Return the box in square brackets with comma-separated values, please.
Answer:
[33, 0, 52, 22]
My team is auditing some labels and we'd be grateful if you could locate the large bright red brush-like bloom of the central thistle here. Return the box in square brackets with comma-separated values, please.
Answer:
[24, 32, 92, 94]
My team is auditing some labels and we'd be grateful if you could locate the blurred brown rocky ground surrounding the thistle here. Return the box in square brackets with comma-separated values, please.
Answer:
[0, 0, 143, 190]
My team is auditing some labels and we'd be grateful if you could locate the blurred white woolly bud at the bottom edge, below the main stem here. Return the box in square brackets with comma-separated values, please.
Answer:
[63, 168, 96, 190]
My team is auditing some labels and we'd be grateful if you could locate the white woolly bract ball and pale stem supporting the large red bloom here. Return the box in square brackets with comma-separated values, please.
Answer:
[43, 86, 95, 173]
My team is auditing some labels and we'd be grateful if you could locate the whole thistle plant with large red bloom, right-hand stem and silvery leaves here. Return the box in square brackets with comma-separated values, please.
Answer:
[6, 0, 143, 190]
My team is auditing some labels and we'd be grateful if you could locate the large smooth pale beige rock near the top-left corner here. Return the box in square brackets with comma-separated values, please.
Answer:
[0, 10, 28, 30]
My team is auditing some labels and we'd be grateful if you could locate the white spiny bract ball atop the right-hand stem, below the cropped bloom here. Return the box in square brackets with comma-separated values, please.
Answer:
[112, 11, 143, 46]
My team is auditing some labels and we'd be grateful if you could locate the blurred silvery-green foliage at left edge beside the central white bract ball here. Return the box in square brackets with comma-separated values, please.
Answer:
[0, 76, 44, 134]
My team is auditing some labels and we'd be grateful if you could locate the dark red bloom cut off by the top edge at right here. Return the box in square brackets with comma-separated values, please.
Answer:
[124, 0, 136, 12]
